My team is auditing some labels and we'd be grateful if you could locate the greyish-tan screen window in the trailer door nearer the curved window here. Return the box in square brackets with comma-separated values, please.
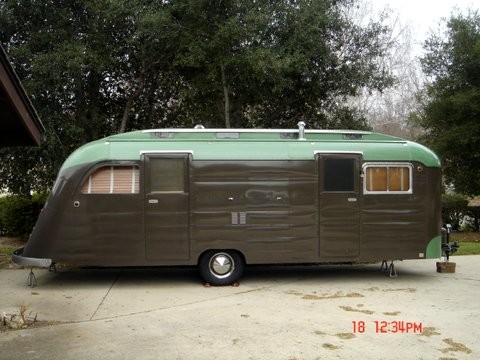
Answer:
[149, 158, 185, 192]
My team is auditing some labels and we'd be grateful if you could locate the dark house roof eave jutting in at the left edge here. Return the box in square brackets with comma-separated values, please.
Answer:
[0, 45, 45, 146]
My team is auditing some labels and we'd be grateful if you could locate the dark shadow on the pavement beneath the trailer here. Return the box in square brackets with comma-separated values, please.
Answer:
[26, 263, 435, 289]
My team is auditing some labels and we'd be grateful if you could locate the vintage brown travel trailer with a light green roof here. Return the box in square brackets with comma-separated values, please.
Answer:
[13, 123, 441, 285]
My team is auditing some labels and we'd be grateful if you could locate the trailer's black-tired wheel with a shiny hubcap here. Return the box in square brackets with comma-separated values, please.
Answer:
[198, 250, 245, 286]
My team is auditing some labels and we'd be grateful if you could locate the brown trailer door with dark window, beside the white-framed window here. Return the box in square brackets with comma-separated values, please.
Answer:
[317, 153, 361, 261]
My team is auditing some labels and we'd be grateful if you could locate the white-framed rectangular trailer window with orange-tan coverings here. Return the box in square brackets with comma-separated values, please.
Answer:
[364, 164, 412, 194]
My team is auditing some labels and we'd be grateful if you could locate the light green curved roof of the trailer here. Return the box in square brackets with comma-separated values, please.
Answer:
[62, 129, 440, 169]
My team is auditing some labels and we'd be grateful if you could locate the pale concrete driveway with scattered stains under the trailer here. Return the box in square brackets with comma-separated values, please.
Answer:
[0, 256, 480, 360]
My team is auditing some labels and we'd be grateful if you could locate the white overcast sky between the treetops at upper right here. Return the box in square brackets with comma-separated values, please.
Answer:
[370, 0, 480, 52]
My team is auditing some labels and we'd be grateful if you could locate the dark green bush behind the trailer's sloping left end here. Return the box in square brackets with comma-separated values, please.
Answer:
[0, 194, 46, 236]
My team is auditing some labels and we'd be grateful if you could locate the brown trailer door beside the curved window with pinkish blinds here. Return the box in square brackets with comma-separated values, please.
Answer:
[144, 153, 190, 263]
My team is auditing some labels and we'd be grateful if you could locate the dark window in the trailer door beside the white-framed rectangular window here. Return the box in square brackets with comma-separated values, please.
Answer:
[323, 158, 355, 192]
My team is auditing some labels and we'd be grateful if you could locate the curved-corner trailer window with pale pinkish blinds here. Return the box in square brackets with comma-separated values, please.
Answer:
[82, 166, 140, 194]
